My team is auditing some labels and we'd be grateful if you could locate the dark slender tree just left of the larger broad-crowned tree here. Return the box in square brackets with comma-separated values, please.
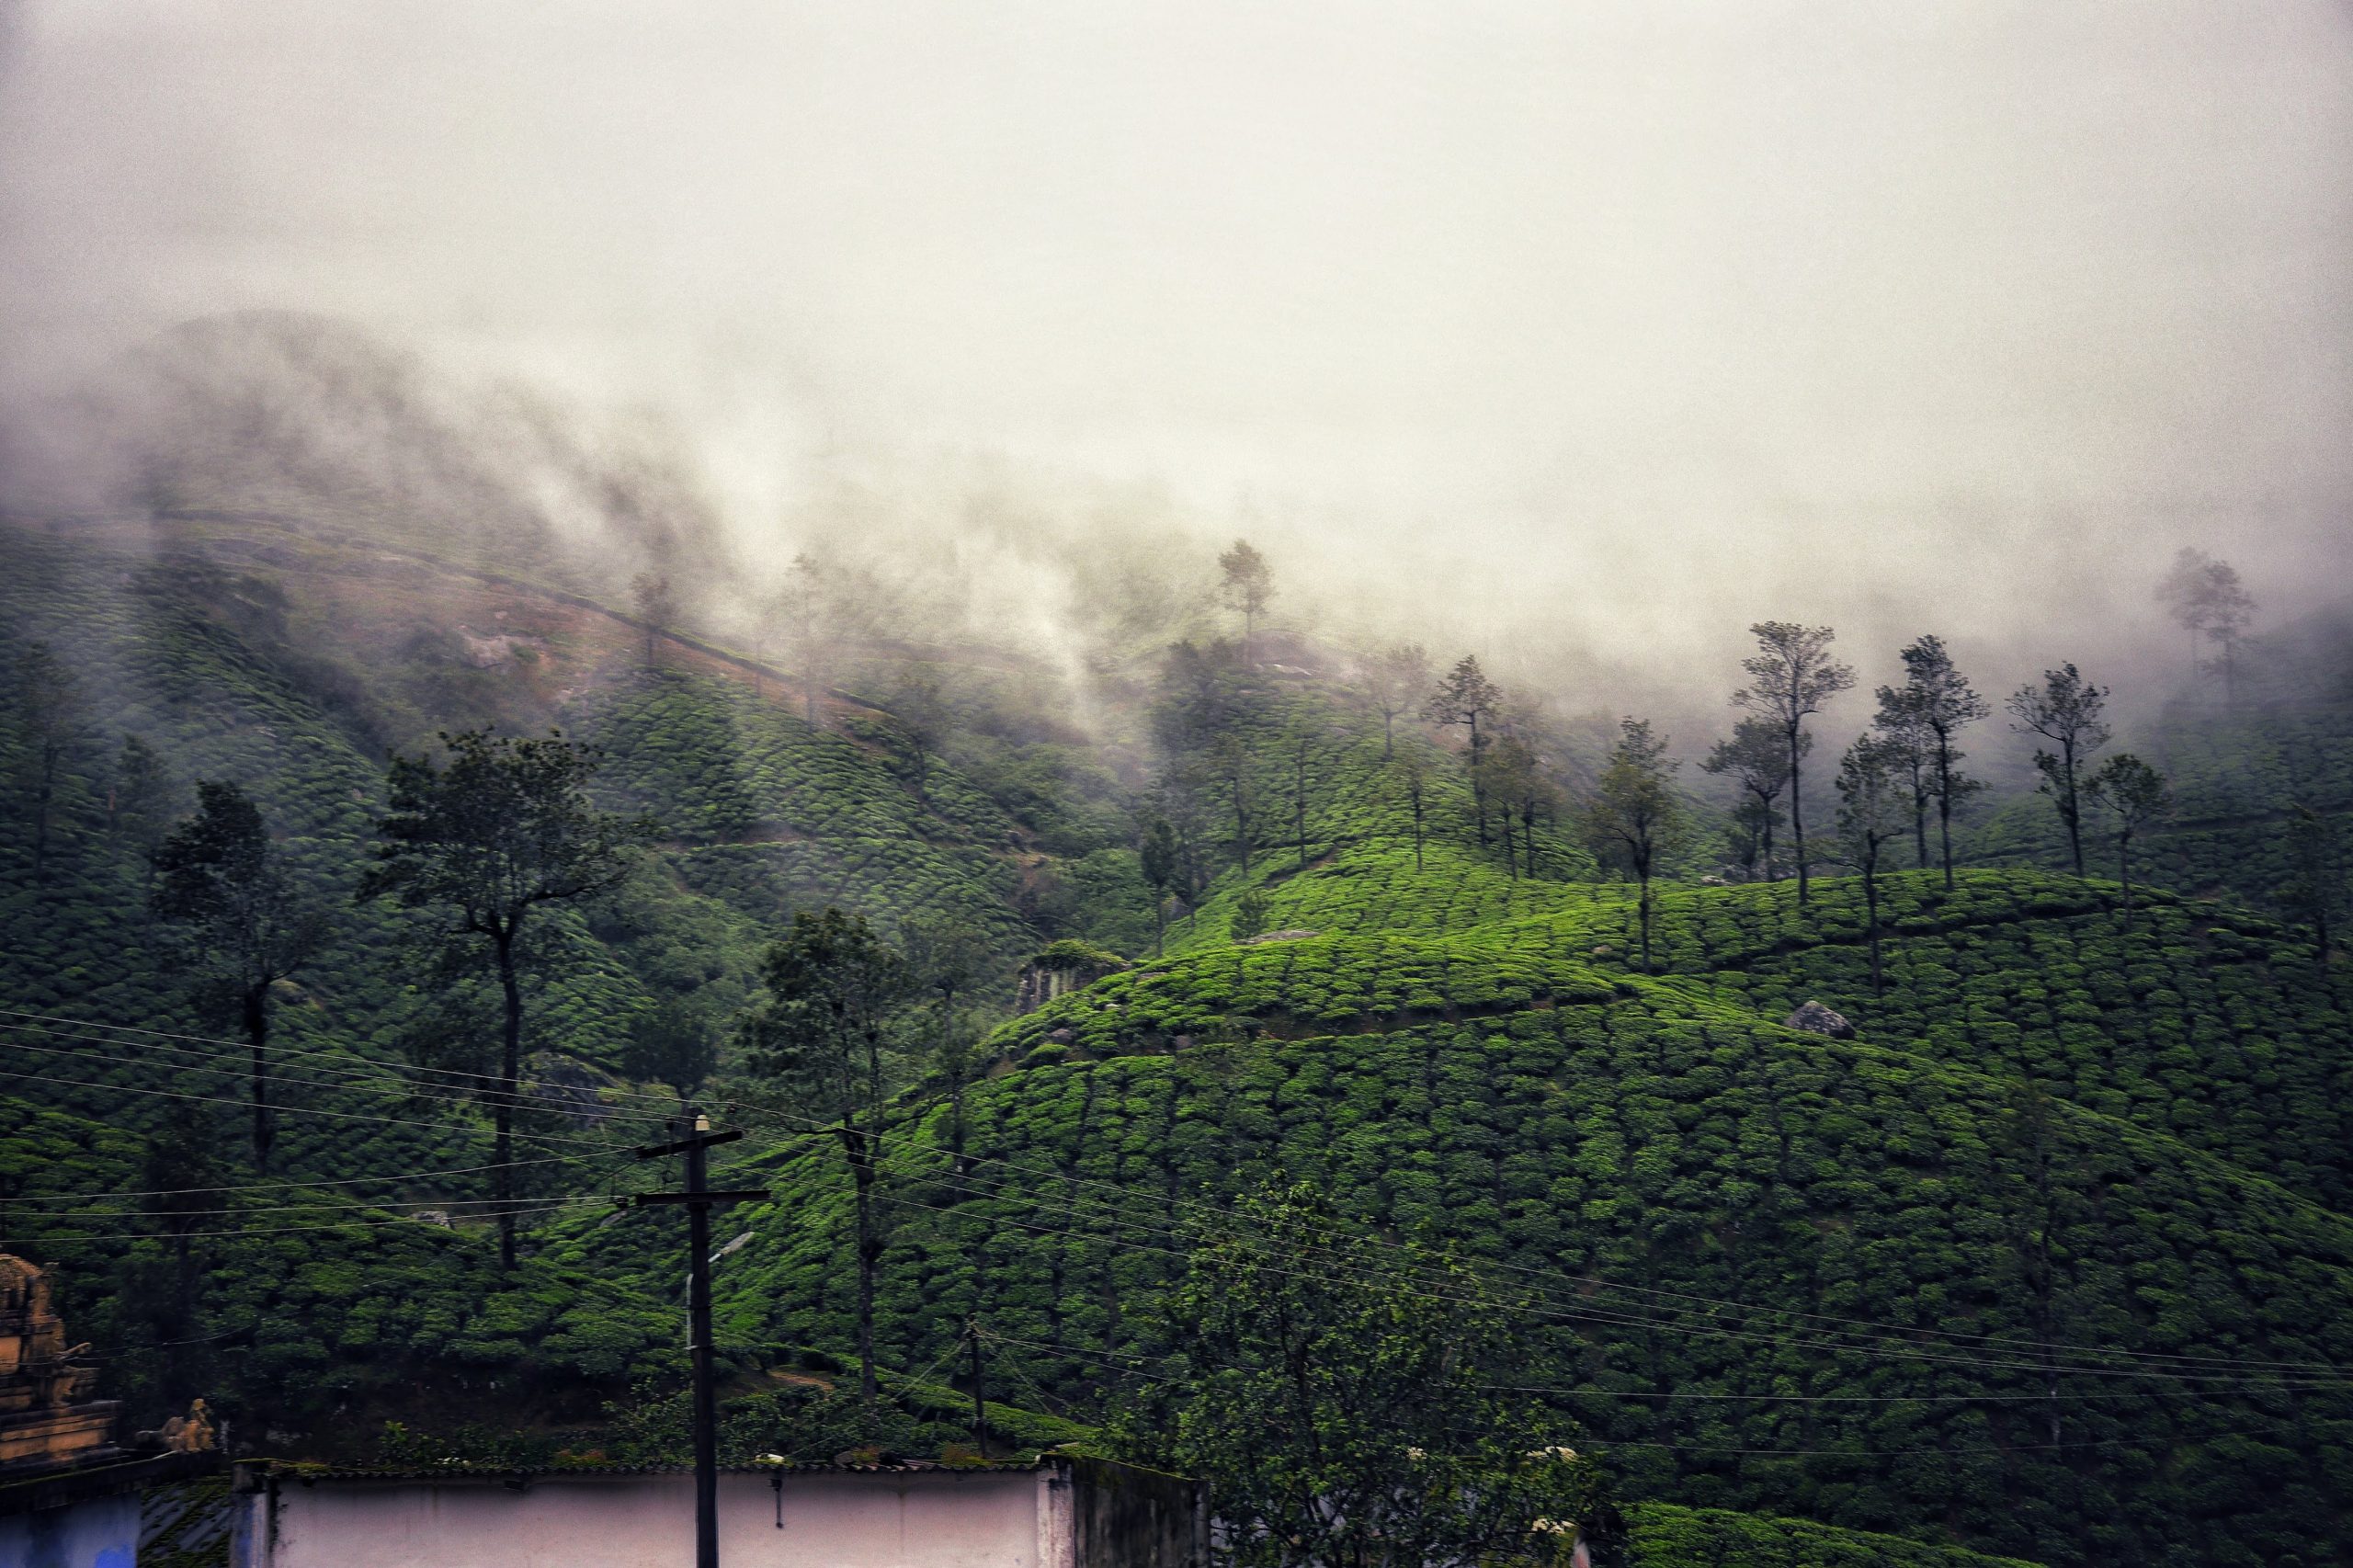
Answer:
[151, 779, 324, 1173]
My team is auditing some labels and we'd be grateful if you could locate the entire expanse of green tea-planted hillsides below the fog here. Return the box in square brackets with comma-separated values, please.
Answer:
[0, 483, 2353, 1565]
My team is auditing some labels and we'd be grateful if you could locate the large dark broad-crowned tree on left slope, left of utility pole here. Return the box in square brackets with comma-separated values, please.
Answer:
[360, 730, 652, 1267]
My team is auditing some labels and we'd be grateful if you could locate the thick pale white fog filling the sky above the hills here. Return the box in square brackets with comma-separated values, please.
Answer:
[0, 0, 2353, 711]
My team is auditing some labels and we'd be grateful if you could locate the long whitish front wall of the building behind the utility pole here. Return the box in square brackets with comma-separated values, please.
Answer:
[235, 1469, 1049, 1568]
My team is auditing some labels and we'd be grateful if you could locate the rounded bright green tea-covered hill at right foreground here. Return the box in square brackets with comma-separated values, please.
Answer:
[540, 846, 2353, 1563]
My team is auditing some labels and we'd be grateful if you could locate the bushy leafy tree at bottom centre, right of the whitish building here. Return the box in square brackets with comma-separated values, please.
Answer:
[1110, 1184, 1621, 1568]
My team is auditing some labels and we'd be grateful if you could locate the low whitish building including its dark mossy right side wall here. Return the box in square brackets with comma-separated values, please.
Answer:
[231, 1455, 1207, 1568]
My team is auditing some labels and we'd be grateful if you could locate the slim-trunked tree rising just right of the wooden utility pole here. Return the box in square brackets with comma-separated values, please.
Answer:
[741, 909, 913, 1413]
